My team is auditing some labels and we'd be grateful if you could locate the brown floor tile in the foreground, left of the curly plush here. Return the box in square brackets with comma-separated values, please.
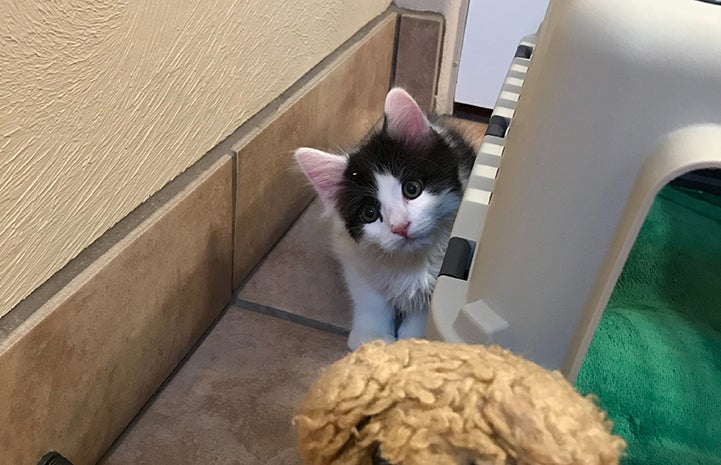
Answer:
[99, 307, 346, 465]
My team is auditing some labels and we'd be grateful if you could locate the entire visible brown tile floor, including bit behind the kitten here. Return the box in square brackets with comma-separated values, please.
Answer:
[99, 121, 485, 465]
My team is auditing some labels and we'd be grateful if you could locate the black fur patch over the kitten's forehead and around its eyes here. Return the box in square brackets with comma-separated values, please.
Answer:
[336, 124, 475, 241]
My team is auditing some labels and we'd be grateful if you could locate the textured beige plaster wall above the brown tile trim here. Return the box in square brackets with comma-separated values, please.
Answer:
[0, 0, 390, 316]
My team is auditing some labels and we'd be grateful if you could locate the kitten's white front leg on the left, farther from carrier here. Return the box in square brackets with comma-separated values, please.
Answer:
[343, 264, 396, 350]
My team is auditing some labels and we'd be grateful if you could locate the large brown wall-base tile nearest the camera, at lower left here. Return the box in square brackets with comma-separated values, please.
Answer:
[0, 155, 233, 463]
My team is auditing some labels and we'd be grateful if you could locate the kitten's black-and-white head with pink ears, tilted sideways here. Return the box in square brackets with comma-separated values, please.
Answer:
[295, 88, 462, 253]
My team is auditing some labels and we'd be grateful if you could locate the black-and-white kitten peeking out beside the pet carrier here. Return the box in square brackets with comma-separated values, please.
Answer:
[295, 88, 475, 350]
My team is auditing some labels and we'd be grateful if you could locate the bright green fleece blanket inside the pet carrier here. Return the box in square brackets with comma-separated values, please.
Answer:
[577, 187, 721, 465]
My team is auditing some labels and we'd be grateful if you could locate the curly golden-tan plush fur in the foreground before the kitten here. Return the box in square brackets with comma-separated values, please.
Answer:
[296, 339, 625, 465]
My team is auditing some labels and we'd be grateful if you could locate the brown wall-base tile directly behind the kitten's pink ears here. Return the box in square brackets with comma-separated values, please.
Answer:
[231, 13, 397, 287]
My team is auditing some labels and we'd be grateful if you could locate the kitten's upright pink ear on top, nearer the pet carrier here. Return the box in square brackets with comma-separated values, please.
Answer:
[385, 87, 431, 143]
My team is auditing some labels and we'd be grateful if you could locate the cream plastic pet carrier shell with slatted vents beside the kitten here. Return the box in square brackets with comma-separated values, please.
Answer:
[427, 0, 721, 380]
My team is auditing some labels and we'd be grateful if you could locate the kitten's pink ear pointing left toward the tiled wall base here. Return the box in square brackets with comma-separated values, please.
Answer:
[294, 147, 348, 208]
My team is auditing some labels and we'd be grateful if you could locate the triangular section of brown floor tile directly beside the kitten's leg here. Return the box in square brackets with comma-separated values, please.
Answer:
[238, 199, 351, 329]
